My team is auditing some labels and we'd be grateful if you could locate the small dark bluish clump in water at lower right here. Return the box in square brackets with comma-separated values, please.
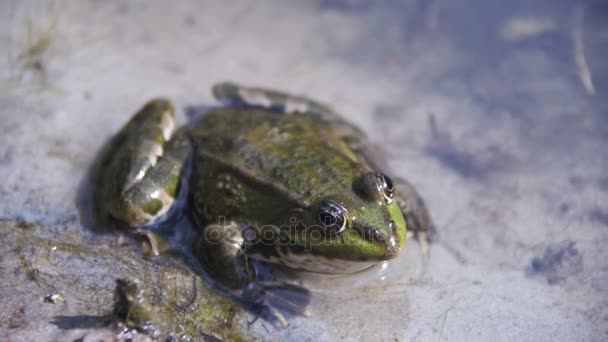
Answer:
[526, 241, 583, 285]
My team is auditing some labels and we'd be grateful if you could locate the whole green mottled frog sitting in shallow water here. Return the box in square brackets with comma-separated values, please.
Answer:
[97, 82, 430, 324]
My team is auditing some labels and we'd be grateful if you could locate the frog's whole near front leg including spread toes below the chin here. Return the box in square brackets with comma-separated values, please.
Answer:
[195, 221, 310, 326]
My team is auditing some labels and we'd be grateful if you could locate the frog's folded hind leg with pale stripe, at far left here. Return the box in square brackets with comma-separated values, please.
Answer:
[96, 99, 190, 253]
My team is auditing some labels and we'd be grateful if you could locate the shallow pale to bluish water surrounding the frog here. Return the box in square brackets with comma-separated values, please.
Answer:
[0, 0, 608, 341]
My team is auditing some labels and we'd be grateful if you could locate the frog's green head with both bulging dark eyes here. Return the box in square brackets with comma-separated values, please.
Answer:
[278, 172, 406, 273]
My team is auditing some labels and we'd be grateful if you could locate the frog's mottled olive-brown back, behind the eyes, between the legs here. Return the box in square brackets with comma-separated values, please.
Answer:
[192, 108, 364, 216]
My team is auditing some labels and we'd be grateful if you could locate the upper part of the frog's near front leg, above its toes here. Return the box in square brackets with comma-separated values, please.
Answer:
[195, 221, 255, 290]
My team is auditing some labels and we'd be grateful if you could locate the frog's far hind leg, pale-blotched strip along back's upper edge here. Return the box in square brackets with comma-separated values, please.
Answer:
[213, 82, 365, 141]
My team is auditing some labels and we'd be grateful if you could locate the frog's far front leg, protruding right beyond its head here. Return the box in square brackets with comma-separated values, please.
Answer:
[395, 178, 436, 260]
